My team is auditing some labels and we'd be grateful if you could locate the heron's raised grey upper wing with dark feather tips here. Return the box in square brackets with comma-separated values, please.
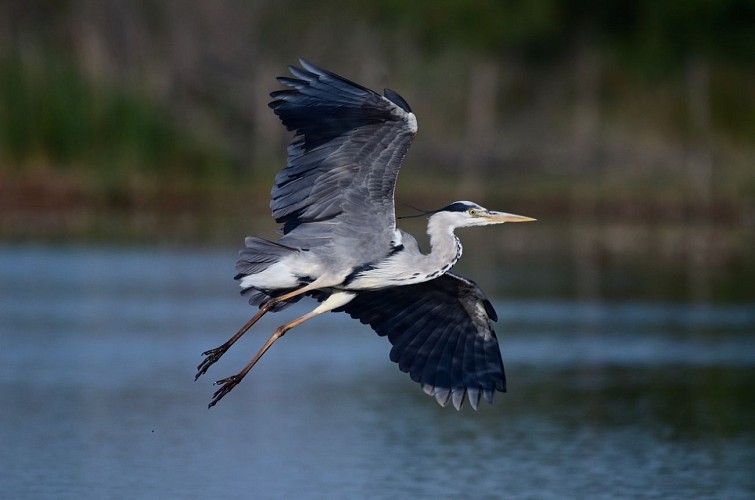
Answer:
[270, 60, 417, 252]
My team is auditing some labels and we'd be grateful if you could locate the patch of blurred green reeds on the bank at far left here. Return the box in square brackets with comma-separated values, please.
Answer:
[0, 54, 229, 187]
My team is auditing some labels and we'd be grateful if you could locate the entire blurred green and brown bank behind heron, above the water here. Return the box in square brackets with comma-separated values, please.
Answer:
[0, 0, 755, 238]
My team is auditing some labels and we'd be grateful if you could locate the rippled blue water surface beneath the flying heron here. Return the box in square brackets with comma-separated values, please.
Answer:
[0, 247, 755, 499]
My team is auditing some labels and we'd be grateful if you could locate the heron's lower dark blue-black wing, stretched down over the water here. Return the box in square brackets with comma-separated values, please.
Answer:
[336, 273, 506, 410]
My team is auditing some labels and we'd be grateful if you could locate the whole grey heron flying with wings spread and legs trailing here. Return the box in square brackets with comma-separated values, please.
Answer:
[195, 60, 535, 410]
